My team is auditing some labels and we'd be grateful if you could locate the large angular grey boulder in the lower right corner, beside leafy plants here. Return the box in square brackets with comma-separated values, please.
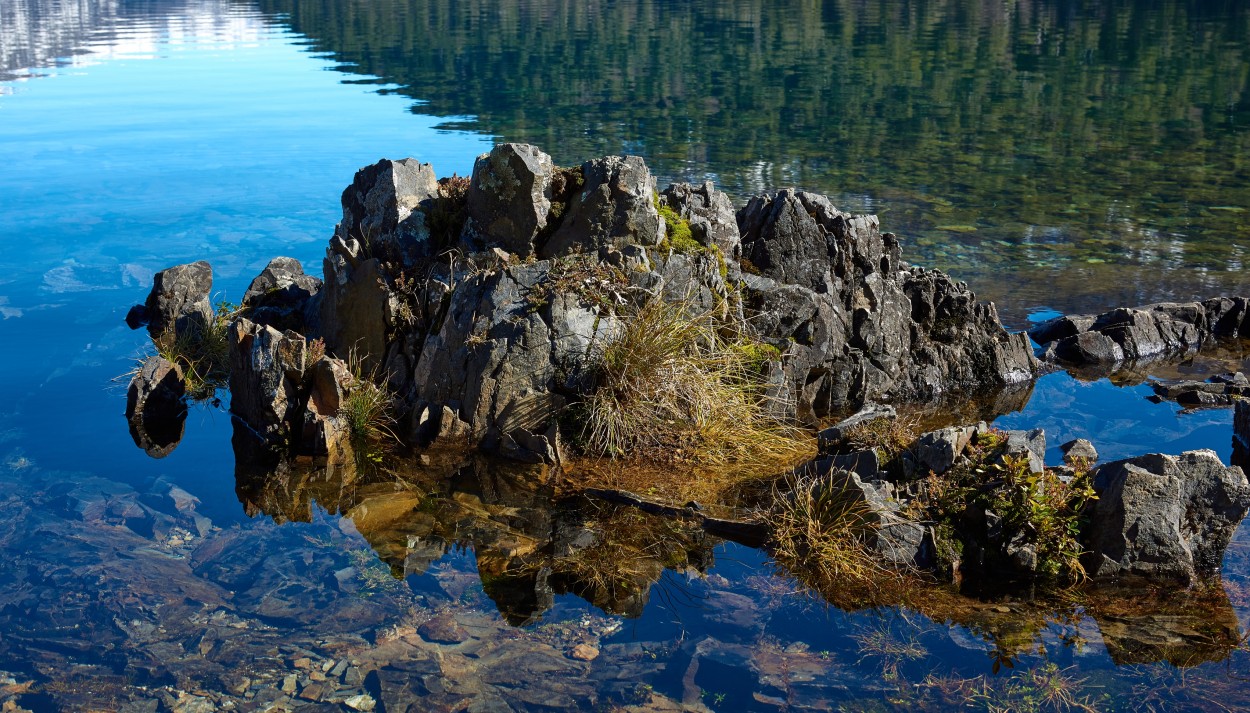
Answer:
[1085, 450, 1250, 582]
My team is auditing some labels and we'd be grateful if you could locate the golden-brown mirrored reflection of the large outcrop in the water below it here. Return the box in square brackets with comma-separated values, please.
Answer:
[234, 432, 719, 625]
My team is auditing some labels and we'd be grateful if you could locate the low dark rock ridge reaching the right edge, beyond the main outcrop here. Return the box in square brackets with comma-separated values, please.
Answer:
[1029, 298, 1250, 372]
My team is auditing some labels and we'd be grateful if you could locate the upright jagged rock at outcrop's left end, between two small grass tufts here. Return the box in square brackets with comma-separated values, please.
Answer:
[229, 318, 308, 439]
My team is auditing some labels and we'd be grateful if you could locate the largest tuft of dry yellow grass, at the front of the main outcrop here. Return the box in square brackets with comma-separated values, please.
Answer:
[583, 299, 815, 472]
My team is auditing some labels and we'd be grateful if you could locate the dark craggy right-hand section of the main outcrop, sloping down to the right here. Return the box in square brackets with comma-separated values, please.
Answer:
[738, 190, 1036, 422]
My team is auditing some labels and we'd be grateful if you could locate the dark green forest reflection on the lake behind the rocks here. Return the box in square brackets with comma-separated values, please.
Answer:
[259, 0, 1250, 323]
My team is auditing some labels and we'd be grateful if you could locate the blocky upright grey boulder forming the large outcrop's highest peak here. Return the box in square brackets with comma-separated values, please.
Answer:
[463, 144, 555, 258]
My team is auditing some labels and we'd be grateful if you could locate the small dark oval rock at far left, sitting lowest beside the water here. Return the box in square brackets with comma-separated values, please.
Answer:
[126, 355, 186, 458]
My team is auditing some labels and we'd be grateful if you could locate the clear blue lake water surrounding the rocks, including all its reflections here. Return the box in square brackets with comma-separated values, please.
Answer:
[0, 0, 1250, 713]
